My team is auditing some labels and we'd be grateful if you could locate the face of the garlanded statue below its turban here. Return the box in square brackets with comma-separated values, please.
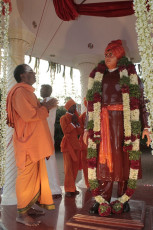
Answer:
[105, 50, 118, 69]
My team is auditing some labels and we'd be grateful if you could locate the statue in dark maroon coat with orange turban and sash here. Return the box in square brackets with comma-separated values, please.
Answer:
[86, 40, 150, 214]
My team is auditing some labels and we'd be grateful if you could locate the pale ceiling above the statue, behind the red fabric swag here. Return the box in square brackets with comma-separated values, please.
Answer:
[16, 0, 140, 67]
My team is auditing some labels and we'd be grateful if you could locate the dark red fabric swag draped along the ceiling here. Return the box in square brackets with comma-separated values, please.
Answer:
[53, 0, 134, 21]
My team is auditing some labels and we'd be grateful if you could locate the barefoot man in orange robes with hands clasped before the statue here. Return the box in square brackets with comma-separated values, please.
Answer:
[7, 64, 57, 226]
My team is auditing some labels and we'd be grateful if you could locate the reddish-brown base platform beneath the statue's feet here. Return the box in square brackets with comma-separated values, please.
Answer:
[66, 199, 145, 230]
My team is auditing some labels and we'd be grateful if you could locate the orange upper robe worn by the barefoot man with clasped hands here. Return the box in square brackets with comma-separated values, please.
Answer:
[7, 83, 54, 169]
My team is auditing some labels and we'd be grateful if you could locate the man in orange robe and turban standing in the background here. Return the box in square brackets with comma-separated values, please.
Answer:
[60, 99, 82, 197]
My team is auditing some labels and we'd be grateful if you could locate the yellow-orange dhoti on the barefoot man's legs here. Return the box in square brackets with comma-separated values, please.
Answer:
[16, 156, 55, 213]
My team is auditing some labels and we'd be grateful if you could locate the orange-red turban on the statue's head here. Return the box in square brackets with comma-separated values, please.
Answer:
[105, 40, 125, 59]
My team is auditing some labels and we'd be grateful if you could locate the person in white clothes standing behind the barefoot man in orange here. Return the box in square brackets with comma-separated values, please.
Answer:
[40, 84, 62, 198]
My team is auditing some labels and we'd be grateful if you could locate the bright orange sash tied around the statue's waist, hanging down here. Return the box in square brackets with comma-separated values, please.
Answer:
[99, 105, 123, 172]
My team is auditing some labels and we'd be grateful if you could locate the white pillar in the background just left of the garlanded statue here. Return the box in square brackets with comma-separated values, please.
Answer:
[77, 61, 95, 188]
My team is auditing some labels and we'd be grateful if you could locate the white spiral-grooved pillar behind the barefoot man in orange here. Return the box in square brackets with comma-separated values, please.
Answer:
[1, 38, 29, 205]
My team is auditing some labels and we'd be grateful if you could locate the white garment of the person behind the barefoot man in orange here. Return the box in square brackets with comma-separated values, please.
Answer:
[43, 97, 62, 195]
